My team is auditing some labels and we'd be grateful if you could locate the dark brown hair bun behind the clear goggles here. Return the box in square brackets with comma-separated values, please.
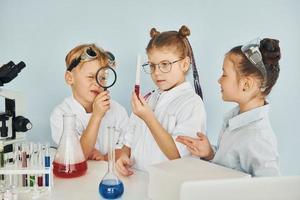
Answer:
[260, 38, 281, 65]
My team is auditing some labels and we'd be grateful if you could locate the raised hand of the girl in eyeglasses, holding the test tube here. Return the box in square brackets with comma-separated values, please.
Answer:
[131, 92, 154, 121]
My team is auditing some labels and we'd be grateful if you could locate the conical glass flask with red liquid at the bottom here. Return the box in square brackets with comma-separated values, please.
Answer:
[53, 114, 87, 178]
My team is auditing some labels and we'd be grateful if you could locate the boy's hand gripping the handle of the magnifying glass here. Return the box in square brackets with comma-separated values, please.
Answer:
[93, 91, 110, 118]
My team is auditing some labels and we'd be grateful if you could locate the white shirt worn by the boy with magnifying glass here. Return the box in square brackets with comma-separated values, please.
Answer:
[50, 96, 129, 154]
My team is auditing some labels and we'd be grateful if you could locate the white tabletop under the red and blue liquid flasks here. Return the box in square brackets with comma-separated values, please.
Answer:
[49, 161, 149, 200]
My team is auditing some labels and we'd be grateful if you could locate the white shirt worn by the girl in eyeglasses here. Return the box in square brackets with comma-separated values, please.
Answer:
[124, 82, 206, 170]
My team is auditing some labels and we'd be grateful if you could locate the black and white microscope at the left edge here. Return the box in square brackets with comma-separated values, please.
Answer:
[0, 61, 32, 153]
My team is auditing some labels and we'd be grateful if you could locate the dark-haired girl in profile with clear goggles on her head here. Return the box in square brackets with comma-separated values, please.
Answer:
[176, 38, 281, 176]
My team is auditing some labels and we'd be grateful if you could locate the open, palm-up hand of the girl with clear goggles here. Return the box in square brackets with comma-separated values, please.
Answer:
[176, 133, 214, 160]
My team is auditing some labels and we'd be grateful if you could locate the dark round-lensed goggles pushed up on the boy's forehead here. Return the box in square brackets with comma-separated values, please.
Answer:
[67, 47, 115, 71]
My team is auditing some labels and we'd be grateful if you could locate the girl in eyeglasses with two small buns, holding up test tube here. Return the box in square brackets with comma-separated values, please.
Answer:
[116, 26, 206, 176]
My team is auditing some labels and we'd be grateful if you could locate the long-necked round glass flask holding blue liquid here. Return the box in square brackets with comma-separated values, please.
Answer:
[99, 127, 124, 199]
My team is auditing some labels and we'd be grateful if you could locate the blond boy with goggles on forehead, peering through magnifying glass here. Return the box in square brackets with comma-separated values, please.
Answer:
[50, 44, 129, 160]
